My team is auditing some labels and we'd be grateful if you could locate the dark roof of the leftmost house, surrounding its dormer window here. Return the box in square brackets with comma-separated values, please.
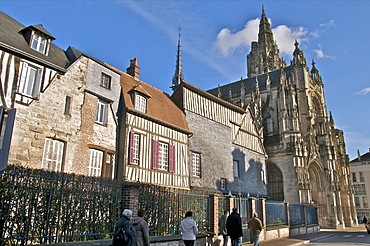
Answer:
[0, 11, 69, 72]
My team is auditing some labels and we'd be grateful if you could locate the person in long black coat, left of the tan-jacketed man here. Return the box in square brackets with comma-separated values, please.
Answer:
[226, 208, 243, 246]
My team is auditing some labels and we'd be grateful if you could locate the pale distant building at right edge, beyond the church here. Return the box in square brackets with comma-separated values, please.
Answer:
[350, 149, 370, 219]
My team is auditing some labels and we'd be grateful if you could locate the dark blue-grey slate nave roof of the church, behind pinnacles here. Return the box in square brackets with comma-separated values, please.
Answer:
[207, 66, 292, 98]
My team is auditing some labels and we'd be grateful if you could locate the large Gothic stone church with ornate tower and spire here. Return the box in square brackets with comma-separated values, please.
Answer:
[208, 10, 356, 228]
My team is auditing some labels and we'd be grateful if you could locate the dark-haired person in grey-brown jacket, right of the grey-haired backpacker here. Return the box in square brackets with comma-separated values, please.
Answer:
[132, 209, 150, 246]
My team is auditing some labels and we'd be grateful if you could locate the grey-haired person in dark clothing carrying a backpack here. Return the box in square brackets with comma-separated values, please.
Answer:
[112, 209, 135, 246]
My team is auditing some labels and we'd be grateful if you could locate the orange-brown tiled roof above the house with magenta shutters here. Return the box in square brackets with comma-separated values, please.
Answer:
[117, 72, 190, 133]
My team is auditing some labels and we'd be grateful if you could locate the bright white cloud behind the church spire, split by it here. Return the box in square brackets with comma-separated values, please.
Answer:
[215, 18, 308, 56]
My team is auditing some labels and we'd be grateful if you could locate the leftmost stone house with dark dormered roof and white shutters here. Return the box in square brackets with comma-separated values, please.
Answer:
[0, 12, 120, 177]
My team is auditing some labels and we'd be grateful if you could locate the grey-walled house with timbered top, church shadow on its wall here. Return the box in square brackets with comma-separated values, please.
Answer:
[172, 81, 267, 197]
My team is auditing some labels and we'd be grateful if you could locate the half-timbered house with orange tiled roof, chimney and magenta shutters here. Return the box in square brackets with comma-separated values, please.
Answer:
[117, 58, 191, 188]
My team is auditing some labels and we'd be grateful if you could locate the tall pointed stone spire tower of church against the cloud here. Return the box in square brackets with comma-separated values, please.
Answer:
[247, 5, 286, 77]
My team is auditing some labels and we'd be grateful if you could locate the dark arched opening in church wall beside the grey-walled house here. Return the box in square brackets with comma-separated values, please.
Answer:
[267, 162, 284, 201]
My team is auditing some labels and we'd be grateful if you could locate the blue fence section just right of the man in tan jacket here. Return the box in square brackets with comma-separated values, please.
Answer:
[266, 201, 288, 226]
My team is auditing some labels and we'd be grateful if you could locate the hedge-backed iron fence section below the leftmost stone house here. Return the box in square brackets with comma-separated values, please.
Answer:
[0, 166, 123, 245]
